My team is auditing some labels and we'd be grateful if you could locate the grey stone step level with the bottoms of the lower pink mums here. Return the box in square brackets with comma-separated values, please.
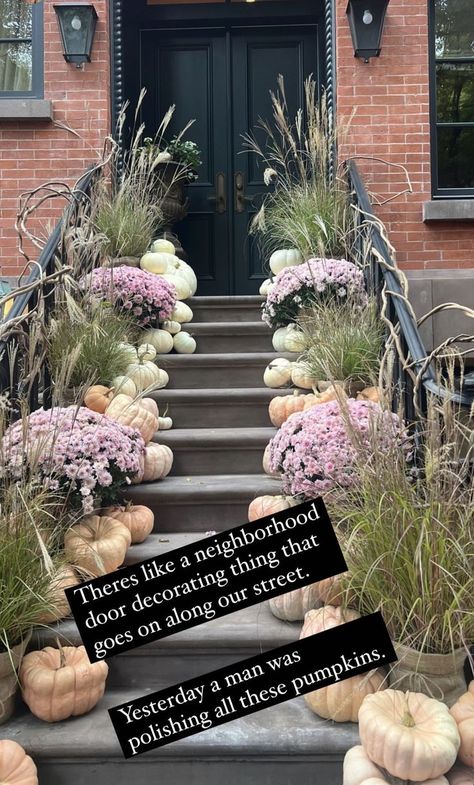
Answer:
[123, 474, 281, 532]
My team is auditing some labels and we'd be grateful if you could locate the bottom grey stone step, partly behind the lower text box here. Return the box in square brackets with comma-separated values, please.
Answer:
[0, 685, 358, 785]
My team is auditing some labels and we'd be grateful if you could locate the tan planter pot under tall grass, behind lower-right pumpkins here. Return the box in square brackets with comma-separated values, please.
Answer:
[389, 643, 467, 706]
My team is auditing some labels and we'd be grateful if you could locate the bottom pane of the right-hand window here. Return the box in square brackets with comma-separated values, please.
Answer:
[438, 128, 474, 188]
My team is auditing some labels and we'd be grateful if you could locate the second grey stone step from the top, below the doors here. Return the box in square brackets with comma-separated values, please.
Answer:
[183, 321, 273, 354]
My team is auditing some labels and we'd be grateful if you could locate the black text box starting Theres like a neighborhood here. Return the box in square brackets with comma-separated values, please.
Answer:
[66, 499, 347, 662]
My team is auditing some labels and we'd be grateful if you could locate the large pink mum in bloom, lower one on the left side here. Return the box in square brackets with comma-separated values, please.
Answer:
[2, 406, 145, 513]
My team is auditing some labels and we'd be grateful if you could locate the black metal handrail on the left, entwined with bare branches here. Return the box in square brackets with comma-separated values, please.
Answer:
[0, 166, 98, 416]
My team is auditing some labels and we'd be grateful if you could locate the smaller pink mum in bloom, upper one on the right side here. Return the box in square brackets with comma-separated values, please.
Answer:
[262, 259, 367, 327]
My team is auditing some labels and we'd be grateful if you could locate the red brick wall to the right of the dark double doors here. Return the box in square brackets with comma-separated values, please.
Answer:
[336, 0, 474, 269]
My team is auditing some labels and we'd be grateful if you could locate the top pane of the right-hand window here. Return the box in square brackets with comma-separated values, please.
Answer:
[435, 0, 474, 57]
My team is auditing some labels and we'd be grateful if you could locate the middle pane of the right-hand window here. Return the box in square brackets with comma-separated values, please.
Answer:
[436, 63, 474, 123]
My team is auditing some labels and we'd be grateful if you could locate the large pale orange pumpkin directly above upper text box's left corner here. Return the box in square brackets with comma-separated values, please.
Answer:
[64, 515, 132, 576]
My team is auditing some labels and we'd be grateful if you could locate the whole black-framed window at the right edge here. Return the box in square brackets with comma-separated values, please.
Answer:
[433, 0, 474, 196]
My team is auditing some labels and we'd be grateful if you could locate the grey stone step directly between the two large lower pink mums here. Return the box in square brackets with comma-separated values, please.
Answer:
[154, 428, 276, 476]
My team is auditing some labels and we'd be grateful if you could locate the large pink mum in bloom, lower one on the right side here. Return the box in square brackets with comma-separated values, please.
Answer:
[270, 399, 405, 499]
